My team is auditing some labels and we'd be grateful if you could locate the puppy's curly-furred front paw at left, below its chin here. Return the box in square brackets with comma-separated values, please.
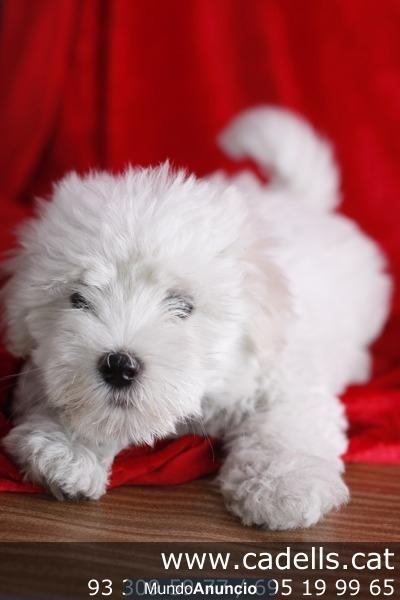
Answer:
[3, 426, 108, 500]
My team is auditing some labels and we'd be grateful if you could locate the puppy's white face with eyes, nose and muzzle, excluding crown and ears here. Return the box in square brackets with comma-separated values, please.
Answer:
[27, 258, 220, 442]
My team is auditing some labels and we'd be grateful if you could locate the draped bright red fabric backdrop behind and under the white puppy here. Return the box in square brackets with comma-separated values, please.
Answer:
[0, 0, 400, 487]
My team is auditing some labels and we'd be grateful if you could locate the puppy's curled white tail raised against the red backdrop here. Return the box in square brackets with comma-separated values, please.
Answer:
[218, 106, 340, 211]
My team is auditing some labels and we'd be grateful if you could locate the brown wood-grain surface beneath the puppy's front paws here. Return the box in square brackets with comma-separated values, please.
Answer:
[0, 465, 400, 542]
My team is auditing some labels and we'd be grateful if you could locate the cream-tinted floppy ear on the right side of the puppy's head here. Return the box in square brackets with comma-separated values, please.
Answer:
[242, 244, 292, 358]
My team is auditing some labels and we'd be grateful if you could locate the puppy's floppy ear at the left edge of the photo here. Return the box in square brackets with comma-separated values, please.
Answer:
[0, 253, 33, 358]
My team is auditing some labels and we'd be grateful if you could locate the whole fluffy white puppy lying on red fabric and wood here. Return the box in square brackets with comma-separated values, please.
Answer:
[3, 108, 390, 529]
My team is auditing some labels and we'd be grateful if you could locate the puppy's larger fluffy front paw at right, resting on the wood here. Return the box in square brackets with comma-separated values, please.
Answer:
[220, 456, 349, 529]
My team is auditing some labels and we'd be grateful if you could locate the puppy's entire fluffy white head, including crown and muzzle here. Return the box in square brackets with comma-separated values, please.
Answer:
[1, 169, 290, 445]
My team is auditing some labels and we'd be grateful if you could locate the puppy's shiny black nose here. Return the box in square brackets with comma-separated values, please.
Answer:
[98, 352, 142, 388]
